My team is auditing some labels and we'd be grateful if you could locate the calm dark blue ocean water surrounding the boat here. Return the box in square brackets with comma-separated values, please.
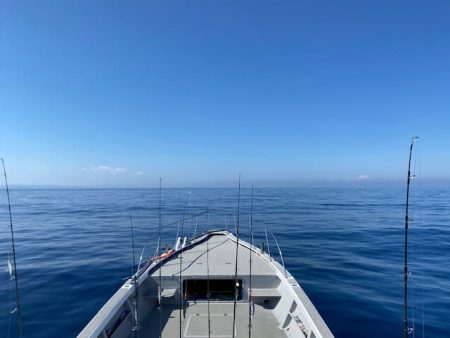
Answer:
[0, 187, 450, 337]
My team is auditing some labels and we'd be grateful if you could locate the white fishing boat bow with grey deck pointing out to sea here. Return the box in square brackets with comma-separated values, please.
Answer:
[78, 209, 333, 338]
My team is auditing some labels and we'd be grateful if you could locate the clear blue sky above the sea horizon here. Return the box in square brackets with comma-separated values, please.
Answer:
[0, 0, 450, 186]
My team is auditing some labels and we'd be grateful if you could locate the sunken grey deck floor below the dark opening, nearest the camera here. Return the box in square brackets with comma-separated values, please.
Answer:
[140, 302, 286, 338]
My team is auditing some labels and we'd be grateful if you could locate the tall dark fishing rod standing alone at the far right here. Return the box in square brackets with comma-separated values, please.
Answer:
[403, 136, 418, 338]
